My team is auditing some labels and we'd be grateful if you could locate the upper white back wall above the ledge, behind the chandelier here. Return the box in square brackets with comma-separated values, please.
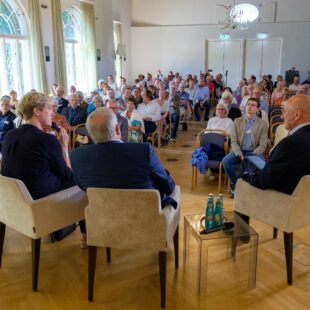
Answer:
[132, 0, 310, 26]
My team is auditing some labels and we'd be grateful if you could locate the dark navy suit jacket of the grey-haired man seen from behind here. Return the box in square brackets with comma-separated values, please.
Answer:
[70, 141, 177, 207]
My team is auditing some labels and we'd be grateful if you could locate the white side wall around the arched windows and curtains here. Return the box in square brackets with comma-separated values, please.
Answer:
[18, 0, 132, 88]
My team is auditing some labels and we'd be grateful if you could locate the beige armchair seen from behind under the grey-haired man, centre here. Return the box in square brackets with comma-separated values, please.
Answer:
[85, 186, 180, 308]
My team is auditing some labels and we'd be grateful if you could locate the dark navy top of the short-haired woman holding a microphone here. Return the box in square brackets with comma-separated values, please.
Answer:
[2, 124, 75, 199]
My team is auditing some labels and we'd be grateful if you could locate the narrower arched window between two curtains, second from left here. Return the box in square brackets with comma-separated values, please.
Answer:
[62, 7, 83, 90]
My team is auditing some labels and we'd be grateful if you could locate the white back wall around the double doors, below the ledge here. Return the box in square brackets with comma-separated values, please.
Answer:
[131, 22, 310, 87]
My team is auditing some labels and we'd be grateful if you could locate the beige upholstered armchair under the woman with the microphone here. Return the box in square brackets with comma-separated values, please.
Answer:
[0, 176, 88, 291]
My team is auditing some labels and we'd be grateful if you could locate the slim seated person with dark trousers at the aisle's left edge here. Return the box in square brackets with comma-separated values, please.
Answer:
[168, 82, 181, 142]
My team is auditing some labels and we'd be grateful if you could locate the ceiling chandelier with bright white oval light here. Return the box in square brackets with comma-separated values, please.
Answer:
[217, 0, 261, 30]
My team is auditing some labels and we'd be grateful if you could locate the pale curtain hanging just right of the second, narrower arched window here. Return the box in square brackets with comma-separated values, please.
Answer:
[80, 2, 97, 91]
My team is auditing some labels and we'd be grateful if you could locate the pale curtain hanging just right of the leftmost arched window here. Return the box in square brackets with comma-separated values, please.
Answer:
[28, 0, 48, 94]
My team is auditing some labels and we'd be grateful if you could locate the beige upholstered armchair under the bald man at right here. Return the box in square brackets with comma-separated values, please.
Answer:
[234, 175, 310, 285]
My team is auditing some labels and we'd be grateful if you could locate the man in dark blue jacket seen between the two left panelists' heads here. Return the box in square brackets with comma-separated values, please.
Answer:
[61, 94, 87, 127]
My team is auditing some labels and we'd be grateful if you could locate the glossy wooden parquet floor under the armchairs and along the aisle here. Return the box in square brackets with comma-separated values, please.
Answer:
[0, 123, 310, 310]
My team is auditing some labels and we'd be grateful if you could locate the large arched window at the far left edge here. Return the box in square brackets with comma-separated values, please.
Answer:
[0, 0, 32, 95]
